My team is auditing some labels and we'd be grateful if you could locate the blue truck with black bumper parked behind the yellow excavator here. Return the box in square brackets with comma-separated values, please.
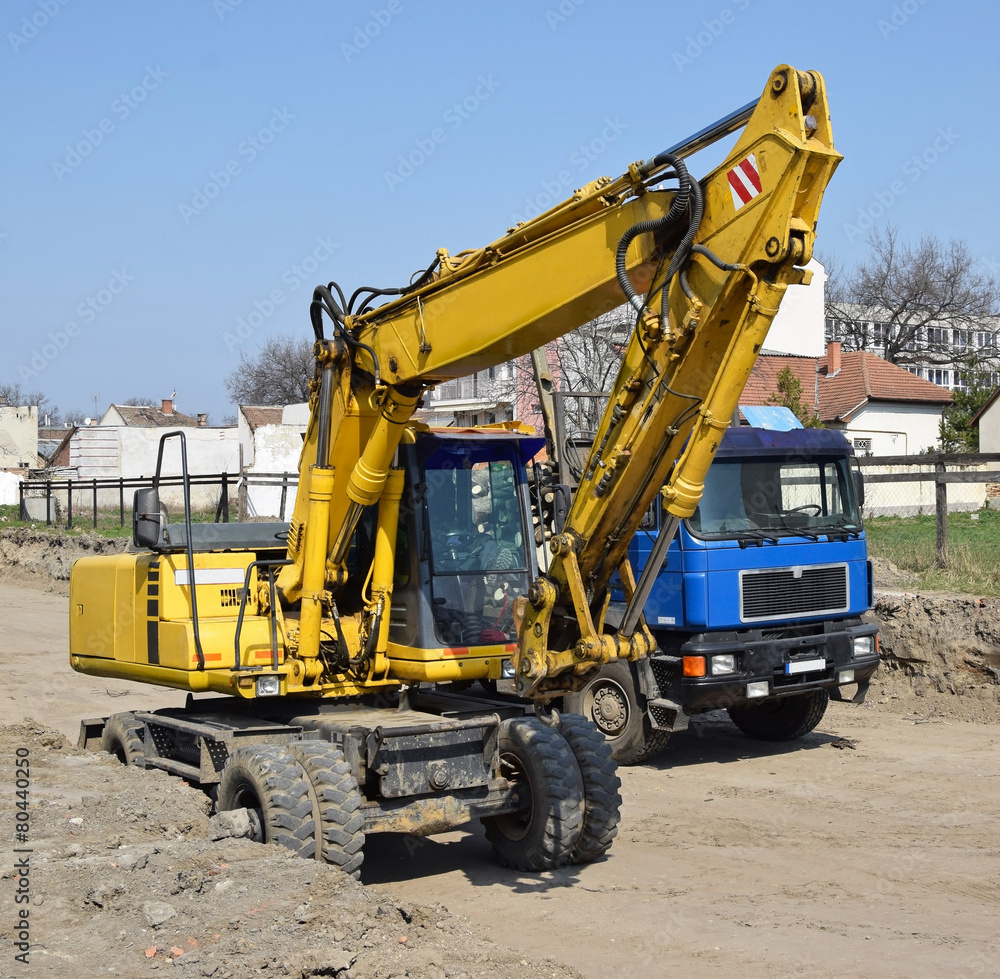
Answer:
[563, 427, 879, 764]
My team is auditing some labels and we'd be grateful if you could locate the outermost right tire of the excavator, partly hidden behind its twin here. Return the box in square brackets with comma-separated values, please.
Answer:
[559, 713, 622, 863]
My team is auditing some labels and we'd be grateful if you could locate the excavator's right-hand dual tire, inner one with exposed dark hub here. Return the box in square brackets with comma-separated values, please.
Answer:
[483, 717, 584, 871]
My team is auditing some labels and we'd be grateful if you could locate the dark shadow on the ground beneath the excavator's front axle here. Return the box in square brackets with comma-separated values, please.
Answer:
[361, 823, 586, 894]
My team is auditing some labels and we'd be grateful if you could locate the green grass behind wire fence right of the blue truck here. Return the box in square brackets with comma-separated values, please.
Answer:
[865, 510, 1000, 595]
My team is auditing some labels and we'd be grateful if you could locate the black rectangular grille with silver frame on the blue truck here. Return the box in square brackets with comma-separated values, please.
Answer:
[740, 564, 848, 622]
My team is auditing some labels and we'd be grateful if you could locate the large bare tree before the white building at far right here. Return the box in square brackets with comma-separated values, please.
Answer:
[826, 226, 998, 370]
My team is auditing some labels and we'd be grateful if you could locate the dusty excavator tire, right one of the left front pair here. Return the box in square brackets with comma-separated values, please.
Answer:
[291, 741, 365, 878]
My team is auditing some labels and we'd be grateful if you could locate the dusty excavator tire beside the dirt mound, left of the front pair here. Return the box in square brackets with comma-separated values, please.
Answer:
[216, 744, 317, 860]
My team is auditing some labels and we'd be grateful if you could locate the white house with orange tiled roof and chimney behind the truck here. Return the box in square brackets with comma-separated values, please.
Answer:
[740, 342, 952, 455]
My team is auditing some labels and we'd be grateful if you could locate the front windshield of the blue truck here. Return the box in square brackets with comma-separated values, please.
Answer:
[687, 458, 861, 539]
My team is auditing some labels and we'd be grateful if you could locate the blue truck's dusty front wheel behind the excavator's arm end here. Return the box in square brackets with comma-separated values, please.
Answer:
[563, 662, 670, 765]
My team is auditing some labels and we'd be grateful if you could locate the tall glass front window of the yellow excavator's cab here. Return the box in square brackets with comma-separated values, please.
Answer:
[425, 447, 529, 646]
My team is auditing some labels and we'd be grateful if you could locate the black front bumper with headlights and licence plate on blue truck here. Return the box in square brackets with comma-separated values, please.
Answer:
[651, 619, 879, 714]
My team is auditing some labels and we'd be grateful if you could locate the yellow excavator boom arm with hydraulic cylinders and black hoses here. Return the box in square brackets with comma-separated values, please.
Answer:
[279, 65, 840, 699]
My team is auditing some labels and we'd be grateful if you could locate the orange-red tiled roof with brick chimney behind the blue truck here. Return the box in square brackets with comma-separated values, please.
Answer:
[740, 350, 952, 422]
